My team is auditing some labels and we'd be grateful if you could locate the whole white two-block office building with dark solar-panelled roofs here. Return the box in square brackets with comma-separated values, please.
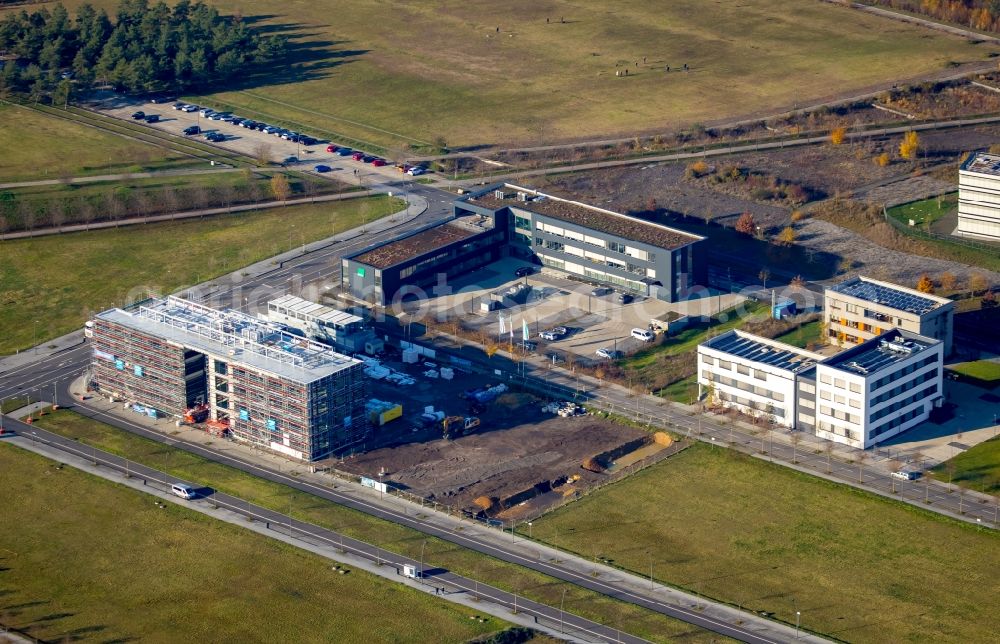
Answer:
[698, 329, 944, 449]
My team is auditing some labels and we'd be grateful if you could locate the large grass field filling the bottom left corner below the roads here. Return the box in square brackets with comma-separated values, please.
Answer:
[0, 445, 506, 642]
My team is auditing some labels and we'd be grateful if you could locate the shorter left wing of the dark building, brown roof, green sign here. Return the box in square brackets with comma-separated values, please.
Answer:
[341, 213, 507, 305]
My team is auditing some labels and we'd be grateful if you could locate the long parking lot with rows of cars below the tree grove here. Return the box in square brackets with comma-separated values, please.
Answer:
[90, 93, 430, 184]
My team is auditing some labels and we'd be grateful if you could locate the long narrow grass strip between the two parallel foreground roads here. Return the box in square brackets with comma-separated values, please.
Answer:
[37, 410, 726, 643]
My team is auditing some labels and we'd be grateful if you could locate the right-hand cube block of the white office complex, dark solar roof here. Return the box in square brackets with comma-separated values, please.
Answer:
[798, 329, 944, 449]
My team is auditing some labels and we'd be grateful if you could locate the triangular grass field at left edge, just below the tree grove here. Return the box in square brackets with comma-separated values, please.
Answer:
[0, 103, 204, 183]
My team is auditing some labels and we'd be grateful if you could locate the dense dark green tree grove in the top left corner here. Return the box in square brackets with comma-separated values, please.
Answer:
[0, 0, 288, 98]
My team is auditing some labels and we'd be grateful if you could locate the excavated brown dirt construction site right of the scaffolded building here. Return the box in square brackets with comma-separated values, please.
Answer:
[327, 348, 673, 520]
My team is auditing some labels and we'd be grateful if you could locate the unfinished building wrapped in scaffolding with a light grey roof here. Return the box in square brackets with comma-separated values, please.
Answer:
[93, 297, 369, 461]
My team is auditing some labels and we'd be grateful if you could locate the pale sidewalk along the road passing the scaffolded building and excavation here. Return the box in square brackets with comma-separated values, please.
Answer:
[71, 380, 825, 642]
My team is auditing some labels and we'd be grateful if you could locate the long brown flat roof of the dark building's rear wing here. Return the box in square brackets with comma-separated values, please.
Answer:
[462, 183, 705, 250]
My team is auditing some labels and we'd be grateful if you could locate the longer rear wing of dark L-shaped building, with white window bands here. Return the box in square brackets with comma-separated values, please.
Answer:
[455, 184, 707, 302]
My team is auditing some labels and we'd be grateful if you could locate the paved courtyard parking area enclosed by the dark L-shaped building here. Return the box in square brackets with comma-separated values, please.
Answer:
[394, 258, 745, 368]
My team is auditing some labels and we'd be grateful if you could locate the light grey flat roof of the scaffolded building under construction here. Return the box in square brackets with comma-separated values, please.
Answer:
[96, 296, 361, 384]
